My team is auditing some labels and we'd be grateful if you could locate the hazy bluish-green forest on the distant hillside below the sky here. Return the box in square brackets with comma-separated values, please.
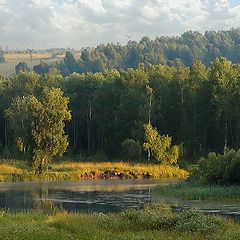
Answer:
[31, 28, 240, 76]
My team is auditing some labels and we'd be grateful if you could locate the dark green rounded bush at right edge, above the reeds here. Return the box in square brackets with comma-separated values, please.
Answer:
[192, 148, 240, 184]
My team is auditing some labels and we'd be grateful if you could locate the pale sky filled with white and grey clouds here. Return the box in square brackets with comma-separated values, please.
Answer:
[0, 0, 240, 49]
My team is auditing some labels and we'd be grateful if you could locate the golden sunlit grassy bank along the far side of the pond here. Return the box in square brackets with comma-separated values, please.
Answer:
[0, 161, 188, 182]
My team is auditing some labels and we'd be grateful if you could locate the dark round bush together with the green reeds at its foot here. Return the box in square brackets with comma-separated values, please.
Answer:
[155, 148, 240, 200]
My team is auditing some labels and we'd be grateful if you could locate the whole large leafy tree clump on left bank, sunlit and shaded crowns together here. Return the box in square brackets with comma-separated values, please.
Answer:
[6, 88, 71, 173]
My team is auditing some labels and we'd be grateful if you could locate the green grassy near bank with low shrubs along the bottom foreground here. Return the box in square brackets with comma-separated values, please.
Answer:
[0, 205, 240, 240]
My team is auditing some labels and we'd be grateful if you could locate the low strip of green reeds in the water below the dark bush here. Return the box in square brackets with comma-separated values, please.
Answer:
[155, 183, 240, 200]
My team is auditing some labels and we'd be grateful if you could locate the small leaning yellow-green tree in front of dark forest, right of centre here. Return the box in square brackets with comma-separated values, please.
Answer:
[143, 123, 179, 164]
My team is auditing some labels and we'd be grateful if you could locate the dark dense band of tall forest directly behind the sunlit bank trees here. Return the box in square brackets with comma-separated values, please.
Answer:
[0, 58, 240, 160]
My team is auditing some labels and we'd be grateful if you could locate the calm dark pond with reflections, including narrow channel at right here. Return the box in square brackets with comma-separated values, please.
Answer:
[0, 179, 240, 222]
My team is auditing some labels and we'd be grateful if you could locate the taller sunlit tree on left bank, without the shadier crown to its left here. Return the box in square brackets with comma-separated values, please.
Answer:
[31, 88, 71, 173]
